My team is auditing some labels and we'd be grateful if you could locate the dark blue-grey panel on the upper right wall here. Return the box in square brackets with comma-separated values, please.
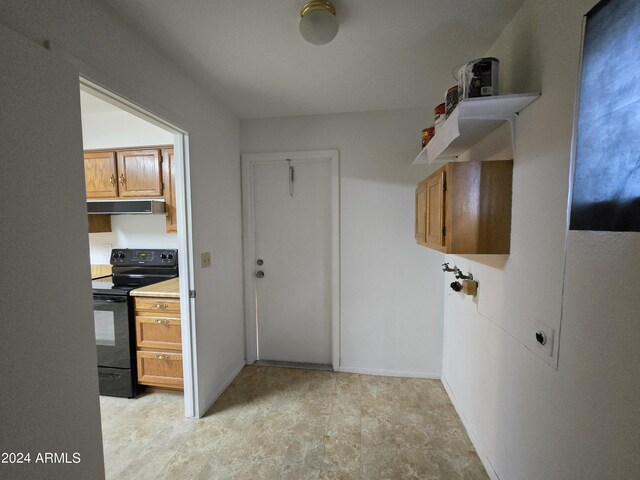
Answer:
[570, 0, 640, 232]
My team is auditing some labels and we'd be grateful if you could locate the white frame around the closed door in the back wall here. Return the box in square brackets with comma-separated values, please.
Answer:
[241, 150, 340, 371]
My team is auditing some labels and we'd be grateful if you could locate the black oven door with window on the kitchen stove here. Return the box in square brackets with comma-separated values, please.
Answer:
[93, 294, 131, 368]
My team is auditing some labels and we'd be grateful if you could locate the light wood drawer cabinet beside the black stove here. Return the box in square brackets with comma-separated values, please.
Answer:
[134, 297, 183, 390]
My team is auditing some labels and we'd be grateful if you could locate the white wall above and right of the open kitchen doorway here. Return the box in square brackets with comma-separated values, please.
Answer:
[0, 0, 244, 438]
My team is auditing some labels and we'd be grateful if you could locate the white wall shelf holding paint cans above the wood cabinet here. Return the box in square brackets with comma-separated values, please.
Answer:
[412, 93, 540, 165]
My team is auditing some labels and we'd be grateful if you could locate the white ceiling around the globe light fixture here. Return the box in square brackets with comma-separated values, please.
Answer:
[103, 0, 523, 119]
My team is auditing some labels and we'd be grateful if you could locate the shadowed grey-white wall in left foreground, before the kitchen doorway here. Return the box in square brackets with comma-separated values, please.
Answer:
[0, 24, 104, 480]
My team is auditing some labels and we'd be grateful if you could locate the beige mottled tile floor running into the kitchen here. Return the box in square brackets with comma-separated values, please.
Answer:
[100, 366, 488, 480]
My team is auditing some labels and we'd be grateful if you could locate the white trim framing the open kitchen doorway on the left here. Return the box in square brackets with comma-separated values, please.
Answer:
[80, 76, 200, 418]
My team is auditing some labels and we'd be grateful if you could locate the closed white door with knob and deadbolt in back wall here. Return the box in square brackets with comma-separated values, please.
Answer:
[252, 158, 332, 364]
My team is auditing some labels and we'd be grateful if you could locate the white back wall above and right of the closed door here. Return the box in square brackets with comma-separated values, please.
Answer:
[241, 109, 444, 377]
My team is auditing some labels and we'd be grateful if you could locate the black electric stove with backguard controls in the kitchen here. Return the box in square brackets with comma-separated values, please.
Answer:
[91, 248, 178, 398]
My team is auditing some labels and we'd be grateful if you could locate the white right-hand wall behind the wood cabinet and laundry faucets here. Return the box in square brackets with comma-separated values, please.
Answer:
[443, 0, 640, 480]
